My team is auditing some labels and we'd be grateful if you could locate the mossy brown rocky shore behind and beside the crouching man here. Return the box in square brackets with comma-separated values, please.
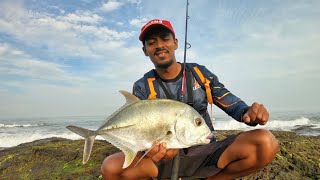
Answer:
[0, 131, 320, 179]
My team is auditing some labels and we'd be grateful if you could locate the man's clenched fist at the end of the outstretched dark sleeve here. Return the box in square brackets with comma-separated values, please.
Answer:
[242, 102, 269, 125]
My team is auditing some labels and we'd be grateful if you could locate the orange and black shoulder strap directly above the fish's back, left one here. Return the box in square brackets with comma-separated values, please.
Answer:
[143, 69, 159, 99]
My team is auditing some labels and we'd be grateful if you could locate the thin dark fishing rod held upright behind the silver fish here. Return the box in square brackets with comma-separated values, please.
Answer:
[170, 0, 191, 180]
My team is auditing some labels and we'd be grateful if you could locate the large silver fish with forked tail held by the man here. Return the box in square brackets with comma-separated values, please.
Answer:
[66, 90, 212, 168]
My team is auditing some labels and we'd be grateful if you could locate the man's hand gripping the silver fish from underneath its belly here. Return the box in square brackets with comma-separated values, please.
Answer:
[146, 143, 179, 163]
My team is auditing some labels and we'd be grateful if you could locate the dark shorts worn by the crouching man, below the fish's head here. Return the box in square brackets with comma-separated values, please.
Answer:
[157, 134, 239, 180]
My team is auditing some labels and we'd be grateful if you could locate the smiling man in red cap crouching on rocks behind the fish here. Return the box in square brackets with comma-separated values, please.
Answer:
[101, 19, 278, 180]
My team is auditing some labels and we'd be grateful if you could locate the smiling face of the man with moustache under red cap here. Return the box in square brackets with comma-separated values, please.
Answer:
[142, 28, 178, 69]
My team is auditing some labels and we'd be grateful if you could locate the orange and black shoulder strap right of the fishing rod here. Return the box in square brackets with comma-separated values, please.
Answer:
[187, 63, 213, 104]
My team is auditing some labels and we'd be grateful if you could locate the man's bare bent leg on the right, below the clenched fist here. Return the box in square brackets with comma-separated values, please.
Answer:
[208, 129, 279, 180]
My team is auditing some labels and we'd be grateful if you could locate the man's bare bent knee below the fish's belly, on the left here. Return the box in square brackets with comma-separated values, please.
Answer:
[101, 152, 158, 180]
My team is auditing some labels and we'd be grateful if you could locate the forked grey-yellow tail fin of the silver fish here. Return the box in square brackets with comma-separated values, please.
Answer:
[67, 126, 97, 164]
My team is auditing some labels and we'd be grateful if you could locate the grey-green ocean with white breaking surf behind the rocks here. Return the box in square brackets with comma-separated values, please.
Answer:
[0, 112, 320, 149]
